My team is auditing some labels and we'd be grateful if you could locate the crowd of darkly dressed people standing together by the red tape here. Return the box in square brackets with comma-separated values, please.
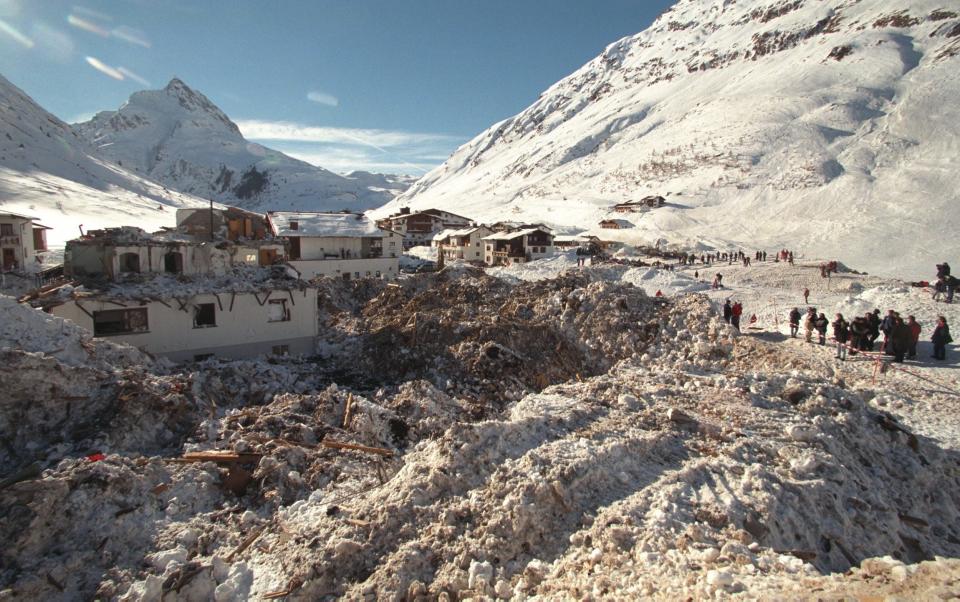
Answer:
[788, 307, 953, 363]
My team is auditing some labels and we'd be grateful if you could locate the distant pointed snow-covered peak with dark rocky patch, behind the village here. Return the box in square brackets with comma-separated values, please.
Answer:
[74, 78, 409, 210]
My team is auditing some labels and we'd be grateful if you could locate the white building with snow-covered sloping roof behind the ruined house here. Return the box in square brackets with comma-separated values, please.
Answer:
[267, 211, 403, 280]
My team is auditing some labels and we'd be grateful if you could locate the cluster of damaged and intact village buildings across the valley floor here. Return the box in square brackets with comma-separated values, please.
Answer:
[16, 204, 644, 361]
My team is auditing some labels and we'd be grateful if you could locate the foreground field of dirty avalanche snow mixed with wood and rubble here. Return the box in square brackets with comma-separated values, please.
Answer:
[0, 268, 960, 600]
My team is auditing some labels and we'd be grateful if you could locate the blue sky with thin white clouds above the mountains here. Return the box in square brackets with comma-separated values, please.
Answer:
[0, 0, 672, 175]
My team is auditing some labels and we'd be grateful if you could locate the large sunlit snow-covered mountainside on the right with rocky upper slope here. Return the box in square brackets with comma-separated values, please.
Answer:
[375, 0, 960, 278]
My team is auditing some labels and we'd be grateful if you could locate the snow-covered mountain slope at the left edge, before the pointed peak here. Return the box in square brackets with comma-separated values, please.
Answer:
[0, 76, 208, 246]
